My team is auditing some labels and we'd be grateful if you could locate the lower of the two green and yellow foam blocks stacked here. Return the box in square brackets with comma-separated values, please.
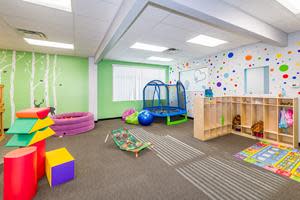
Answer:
[5, 127, 55, 147]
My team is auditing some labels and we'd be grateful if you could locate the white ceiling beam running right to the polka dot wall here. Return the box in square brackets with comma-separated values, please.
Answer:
[155, 0, 288, 47]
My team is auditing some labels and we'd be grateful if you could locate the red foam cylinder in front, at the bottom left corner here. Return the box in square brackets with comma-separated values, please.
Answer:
[3, 147, 37, 200]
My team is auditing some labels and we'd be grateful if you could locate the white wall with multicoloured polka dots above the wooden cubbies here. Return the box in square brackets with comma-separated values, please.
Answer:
[169, 32, 300, 116]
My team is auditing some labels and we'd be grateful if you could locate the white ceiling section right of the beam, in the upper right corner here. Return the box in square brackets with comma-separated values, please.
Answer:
[223, 0, 300, 33]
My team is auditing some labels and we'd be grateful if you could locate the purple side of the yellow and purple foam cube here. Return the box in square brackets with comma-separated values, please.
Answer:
[51, 160, 75, 187]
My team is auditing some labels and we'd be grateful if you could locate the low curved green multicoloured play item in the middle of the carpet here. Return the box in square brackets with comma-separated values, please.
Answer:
[111, 128, 151, 157]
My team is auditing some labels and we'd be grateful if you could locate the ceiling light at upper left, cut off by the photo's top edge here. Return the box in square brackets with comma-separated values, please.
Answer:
[23, 0, 72, 12]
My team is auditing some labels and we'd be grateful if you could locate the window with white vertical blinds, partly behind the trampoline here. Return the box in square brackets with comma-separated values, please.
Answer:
[113, 65, 166, 101]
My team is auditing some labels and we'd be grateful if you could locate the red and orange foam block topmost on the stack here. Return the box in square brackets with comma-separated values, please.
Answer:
[16, 108, 50, 119]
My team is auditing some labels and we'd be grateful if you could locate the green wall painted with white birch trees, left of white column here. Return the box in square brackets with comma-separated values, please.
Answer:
[0, 50, 88, 128]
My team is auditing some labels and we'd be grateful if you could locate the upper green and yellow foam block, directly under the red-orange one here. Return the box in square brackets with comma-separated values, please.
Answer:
[6, 117, 54, 134]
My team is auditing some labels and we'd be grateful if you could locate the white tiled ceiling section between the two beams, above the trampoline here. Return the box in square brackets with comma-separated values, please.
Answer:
[106, 5, 258, 64]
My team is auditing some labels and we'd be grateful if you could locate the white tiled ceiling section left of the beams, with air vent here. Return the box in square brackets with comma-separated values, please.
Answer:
[0, 0, 122, 56]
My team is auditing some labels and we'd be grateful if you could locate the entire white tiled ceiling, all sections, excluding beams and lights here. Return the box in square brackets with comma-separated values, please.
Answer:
[0, 0, 300, 60]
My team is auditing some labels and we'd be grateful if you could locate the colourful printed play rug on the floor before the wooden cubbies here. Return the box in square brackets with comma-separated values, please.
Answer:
[234, 142, 300, 182]
